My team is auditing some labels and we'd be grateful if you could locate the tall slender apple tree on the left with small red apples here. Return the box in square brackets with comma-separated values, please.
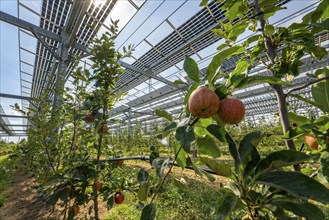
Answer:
[15, 21, 137, 220]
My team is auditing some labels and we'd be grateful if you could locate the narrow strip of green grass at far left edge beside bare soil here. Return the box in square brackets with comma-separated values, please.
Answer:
[0, 154, 15, 207]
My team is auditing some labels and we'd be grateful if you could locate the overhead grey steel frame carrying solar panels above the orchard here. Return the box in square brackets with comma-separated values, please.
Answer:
[0, 0, 329, 138]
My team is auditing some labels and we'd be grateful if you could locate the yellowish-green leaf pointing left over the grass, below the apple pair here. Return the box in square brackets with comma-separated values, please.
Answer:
[200, 157, 232, 177]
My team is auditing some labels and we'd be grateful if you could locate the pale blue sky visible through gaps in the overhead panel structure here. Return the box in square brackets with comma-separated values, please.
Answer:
[0, 0, 316, 141]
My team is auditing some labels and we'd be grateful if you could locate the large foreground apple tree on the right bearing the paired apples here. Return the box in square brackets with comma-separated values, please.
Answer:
[141, 0, 329, 219]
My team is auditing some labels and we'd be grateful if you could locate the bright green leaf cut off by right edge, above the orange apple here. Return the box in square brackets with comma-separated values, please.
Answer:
[312, 70, 329, 113]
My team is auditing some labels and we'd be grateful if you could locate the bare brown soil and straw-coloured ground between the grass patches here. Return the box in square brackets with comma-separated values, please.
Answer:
[0, 161, 227, 220]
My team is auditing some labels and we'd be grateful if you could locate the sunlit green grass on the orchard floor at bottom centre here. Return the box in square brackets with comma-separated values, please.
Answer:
[105, 164, 224, 220]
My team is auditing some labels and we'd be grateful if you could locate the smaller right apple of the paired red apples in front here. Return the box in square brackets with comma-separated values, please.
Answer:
[218, 98, 246, 124]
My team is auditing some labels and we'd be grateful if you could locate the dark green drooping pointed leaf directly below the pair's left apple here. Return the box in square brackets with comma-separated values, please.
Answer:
[175, 125, 195, 153]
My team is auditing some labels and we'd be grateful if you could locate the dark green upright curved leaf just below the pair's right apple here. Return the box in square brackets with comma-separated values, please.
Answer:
[238, 131, 262, 164]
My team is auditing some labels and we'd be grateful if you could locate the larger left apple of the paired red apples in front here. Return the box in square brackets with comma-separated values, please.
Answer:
[188, 87, 219, 118]
